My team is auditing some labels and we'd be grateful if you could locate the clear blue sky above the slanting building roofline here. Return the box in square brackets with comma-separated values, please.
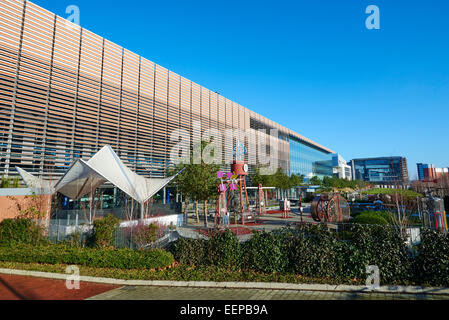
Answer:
[33, 0, 449, 178]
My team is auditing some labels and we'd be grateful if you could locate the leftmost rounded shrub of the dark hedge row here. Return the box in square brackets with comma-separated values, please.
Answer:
[169, 238, 207, 266]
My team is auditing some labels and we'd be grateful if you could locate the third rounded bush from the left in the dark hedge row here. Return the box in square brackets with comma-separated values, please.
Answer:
[242, 231, 287, 273]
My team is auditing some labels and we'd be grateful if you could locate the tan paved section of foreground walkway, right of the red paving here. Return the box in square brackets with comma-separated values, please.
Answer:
[89, 286, 449, 300]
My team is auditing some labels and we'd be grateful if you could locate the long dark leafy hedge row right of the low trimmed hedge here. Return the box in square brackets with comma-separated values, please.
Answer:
[170, 225, 413, 284]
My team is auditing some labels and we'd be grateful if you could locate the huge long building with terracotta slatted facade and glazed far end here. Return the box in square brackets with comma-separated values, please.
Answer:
[0, 0, 333, 188]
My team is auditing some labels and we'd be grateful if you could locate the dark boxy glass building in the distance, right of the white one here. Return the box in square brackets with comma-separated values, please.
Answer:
[350, 157, 409, 186]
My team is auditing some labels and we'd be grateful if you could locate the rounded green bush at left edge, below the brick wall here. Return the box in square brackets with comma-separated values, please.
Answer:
[0, 219, 44, 246]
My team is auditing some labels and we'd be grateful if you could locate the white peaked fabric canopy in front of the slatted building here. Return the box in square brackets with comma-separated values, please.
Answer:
[17, 145, 181, 218]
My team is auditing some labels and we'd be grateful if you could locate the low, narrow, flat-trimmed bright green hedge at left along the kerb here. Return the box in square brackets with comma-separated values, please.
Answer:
[0, 245, 174, 269]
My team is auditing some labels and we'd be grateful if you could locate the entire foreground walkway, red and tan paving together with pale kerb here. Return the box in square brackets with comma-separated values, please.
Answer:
[0, 269, 449, 300]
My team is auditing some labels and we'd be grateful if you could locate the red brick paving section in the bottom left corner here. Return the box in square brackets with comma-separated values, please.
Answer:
[0, 274, 119, 300]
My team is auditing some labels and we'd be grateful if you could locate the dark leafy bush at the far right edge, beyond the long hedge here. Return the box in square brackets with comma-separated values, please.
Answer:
[414, 230, 449, 287]
